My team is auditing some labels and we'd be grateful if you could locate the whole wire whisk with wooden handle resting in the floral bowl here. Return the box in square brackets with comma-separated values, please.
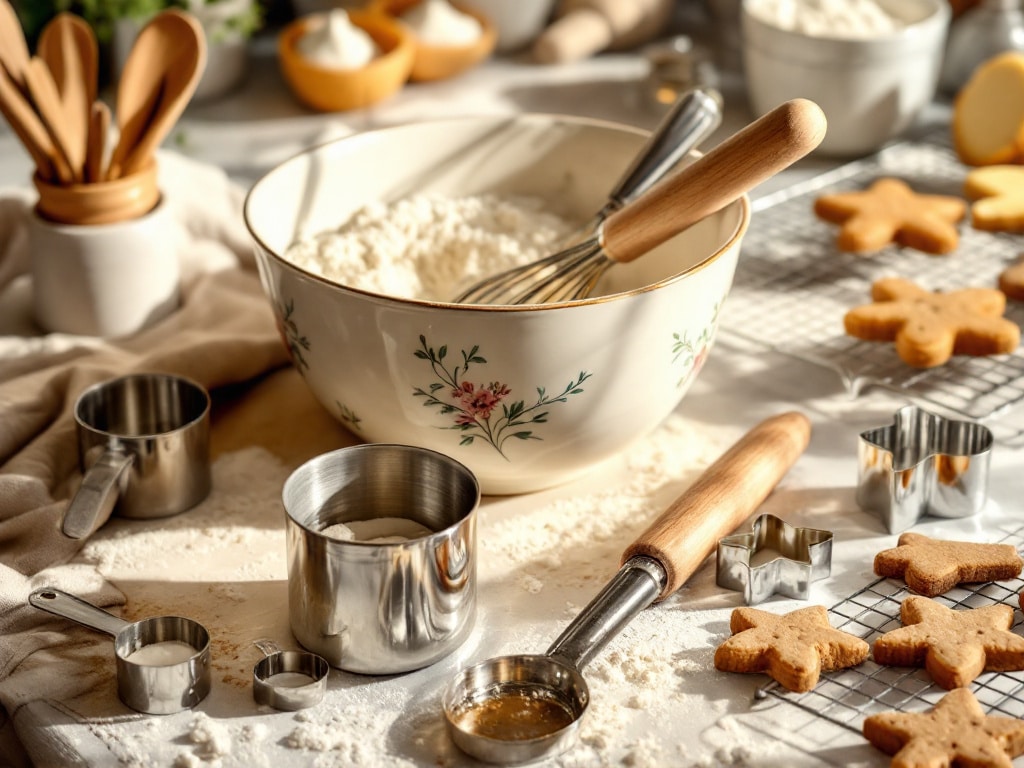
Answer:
[455, 98, 825, 304]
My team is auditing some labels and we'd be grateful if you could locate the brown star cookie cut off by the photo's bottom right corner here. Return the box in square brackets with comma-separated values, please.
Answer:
[863, 688, 1024, 768]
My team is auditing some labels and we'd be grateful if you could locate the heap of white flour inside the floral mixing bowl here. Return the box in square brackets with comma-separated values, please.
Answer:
[285, 195, 571, 301]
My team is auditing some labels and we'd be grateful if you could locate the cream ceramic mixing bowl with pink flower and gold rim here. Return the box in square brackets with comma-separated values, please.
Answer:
[245, 115, 750, 494]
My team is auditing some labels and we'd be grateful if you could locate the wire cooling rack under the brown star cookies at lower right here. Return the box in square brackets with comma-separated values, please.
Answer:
[759, 527, 1024, 743]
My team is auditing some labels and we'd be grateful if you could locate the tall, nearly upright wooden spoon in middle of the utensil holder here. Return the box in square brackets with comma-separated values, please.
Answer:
[36, 12, 99, 175]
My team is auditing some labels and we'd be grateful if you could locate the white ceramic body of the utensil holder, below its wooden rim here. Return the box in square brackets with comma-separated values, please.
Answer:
[29, 202, 180, 337]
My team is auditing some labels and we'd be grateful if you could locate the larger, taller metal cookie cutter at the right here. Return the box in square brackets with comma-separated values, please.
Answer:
[857, 406, 992, 534]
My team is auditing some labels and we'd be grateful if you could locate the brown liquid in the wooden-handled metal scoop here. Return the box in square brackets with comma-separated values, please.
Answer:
[453, 690, 575, 741]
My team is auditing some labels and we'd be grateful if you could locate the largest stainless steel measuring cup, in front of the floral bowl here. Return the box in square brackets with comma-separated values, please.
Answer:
[282, 443, 480, 675]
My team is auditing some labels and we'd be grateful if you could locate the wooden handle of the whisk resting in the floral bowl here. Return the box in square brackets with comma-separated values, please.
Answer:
[601, 98, 825, 262]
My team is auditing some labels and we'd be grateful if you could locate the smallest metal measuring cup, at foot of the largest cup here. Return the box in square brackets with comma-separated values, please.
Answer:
[253, 640, 331, 712]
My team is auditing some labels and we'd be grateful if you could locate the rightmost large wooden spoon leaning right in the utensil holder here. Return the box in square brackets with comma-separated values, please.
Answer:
[106, 9, 206, 179]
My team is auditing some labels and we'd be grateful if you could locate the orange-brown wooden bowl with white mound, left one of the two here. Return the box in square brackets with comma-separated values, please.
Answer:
[278, 10, 416, 112]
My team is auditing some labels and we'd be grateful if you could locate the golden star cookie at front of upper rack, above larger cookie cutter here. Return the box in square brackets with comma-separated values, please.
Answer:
[843, 278, 1021, 368]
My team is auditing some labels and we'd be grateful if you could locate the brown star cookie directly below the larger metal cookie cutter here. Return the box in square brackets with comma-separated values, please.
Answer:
[874, 532, 1024, 597]
